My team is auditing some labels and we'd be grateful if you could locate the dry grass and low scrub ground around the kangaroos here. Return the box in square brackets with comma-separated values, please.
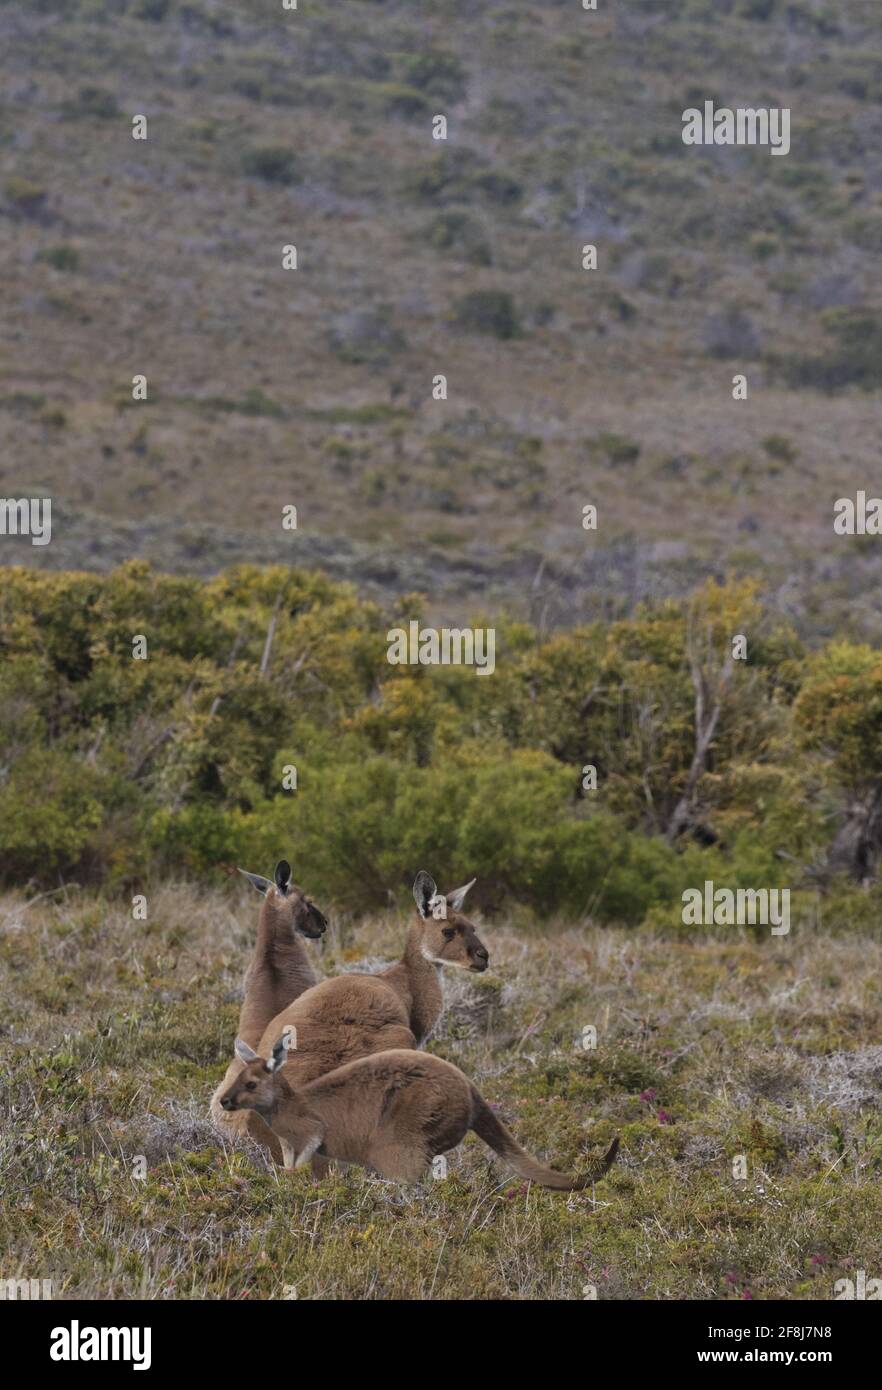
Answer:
[0, 885, 882, 1298]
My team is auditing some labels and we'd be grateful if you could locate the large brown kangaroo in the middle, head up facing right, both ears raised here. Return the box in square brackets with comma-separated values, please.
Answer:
[255, 869, 489, 1086]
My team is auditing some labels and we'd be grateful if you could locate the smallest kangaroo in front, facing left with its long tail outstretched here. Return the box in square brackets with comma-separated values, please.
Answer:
[221, 1034, 618, 1193]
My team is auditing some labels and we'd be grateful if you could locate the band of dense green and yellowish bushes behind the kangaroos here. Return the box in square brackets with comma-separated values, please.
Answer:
[0, 562, 882, 922]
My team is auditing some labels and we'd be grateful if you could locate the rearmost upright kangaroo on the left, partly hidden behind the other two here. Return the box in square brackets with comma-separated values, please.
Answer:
[211, 859, 328, 1163]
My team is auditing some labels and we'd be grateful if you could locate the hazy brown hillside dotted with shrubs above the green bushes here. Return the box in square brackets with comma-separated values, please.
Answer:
[0, 0, 882, 637]
